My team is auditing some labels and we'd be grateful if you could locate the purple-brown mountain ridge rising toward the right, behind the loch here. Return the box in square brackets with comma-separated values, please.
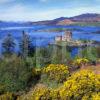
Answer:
[32, 13, 100, 25]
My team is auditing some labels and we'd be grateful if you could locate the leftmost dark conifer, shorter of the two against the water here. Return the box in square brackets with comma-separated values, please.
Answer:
[2, 34, 16, 54]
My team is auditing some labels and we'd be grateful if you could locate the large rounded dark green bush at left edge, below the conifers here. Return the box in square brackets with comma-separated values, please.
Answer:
[0, 57, 32, 92]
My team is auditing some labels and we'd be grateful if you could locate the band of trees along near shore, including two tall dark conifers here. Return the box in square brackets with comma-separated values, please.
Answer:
[2, 31, 100, 67]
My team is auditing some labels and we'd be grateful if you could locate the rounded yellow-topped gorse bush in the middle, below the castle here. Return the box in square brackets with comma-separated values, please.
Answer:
[42, 64, 69, 83]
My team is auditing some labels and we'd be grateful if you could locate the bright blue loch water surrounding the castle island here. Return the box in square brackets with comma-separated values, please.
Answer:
[0, 25, 100, 53]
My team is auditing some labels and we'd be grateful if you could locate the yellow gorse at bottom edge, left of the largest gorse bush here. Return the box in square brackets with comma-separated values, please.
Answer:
[17, 84, 60, 100]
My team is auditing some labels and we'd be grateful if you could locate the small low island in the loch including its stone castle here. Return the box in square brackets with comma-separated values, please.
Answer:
[52, 30, 98, 47]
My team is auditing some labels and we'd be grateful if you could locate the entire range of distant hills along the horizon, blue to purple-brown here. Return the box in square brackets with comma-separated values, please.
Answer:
[0, 13, 100, 27]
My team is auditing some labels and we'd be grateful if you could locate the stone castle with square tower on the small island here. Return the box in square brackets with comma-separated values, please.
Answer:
[55, 31, 72, 42]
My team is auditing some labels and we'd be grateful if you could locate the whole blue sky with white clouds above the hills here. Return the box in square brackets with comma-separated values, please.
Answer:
[0, 0, 100, 21]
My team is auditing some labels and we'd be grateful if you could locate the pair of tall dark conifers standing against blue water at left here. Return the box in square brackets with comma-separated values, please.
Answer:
[2, 31, 34, 58]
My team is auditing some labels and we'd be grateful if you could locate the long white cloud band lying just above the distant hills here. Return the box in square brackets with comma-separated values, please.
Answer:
[0, 4, 100, 21]
